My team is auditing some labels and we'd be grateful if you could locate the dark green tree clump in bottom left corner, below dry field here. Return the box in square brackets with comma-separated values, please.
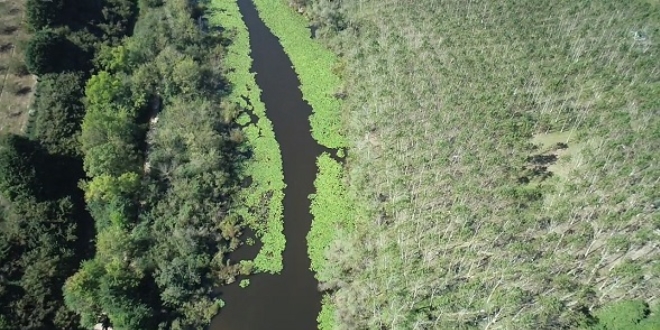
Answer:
[0, 145, 85, 329]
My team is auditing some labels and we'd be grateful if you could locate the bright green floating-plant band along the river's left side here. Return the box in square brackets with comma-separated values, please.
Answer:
[208, 0, 285, 273]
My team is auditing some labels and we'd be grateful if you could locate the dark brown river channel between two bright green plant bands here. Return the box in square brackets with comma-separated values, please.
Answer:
[210, 0, 324, 330]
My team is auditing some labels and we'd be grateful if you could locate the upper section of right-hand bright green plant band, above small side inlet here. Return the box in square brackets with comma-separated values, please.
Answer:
[254, 0, 347, 148]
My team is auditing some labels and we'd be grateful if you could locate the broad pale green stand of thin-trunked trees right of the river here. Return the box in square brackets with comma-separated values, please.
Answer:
[298, 0, 660, 329]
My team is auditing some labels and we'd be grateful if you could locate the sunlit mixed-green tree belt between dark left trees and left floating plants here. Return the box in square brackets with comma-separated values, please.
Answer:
[64, 0, 252, 330]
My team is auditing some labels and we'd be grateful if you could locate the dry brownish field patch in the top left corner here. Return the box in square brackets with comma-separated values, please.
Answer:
[0, 0, 36, 133]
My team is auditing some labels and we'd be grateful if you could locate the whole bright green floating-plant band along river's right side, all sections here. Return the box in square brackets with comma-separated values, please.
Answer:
[246, 0, 356, 329]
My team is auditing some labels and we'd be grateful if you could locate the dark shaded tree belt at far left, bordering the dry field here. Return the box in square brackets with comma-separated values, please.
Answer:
[0, 0, 136, 329]
